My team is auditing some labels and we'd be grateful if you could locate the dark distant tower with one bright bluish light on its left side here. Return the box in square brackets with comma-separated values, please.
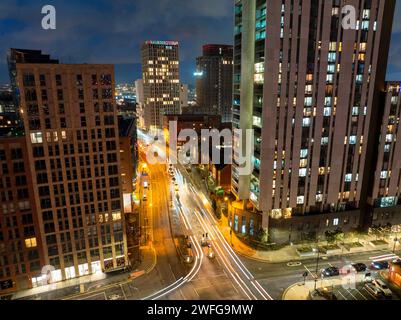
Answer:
[195, 44, 233, 122]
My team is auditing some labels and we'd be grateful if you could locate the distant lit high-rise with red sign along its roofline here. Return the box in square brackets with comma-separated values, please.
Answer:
[142, 41, 181, 129]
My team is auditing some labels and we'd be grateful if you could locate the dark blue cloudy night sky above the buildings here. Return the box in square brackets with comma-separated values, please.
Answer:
[0, 0, 401, 84]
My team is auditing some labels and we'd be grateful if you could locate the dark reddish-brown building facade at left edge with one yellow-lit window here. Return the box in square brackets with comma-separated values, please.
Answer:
[0, 133, 45, 294]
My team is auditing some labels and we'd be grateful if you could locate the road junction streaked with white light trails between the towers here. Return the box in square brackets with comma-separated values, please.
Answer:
[14, 129, 398, 300]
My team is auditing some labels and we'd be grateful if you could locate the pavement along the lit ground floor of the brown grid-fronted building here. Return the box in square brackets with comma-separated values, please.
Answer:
[12, 246, 157, 300]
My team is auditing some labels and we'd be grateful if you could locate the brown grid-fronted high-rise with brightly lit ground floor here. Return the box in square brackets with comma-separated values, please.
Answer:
[11, 52, 127, 286]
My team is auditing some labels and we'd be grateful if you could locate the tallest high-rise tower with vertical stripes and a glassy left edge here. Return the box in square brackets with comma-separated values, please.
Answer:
[232, 0, 395, 240]
